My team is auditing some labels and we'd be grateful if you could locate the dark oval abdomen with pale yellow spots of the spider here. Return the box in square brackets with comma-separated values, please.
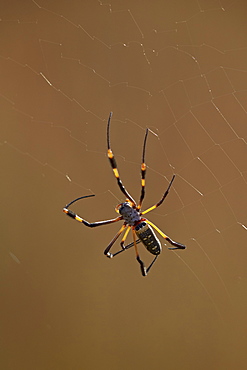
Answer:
[135, 221, 161, 255]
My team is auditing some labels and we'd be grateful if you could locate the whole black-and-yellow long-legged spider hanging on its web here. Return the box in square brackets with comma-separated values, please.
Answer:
[63, 112, 186, 276]
